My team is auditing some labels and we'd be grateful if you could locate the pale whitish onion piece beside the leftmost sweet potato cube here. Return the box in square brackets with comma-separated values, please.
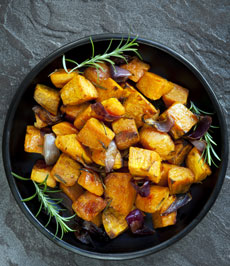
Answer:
[43, 133, 60, 165]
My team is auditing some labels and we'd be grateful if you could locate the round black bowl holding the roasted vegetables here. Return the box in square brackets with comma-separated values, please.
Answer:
[3, 34, 228, 260]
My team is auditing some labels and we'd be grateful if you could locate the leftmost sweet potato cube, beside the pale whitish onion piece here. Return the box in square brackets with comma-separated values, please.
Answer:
[24, 126, 44, 153]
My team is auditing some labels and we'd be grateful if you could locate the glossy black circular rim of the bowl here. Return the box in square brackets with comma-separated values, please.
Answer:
[2, 33, 228, 260]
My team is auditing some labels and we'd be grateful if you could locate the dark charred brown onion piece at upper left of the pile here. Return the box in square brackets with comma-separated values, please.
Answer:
[32, 105, 62, 126]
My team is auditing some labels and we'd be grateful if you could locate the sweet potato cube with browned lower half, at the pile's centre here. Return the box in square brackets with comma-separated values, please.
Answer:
[112, 118, 140, 150]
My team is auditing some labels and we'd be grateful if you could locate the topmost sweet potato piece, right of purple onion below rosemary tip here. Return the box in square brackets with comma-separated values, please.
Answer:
[120, 57, 150, 82]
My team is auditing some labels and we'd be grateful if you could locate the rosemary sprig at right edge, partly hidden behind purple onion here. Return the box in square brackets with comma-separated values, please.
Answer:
[189, 101, 221, 167]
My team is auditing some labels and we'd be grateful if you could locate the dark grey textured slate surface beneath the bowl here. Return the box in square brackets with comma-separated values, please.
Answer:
[0, 0, 230, 266]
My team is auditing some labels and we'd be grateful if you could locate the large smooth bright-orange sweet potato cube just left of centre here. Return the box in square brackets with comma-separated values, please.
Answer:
[77, 118, 115, 150]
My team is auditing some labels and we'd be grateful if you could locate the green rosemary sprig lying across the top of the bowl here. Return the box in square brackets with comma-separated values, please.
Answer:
[62, 36, 141, 73]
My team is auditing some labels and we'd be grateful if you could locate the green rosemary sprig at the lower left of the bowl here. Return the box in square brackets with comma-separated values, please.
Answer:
[11, 172, 75, 239]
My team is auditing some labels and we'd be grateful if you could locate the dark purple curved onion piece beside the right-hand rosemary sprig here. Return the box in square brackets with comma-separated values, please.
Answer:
[186, 115, 212, 140]
